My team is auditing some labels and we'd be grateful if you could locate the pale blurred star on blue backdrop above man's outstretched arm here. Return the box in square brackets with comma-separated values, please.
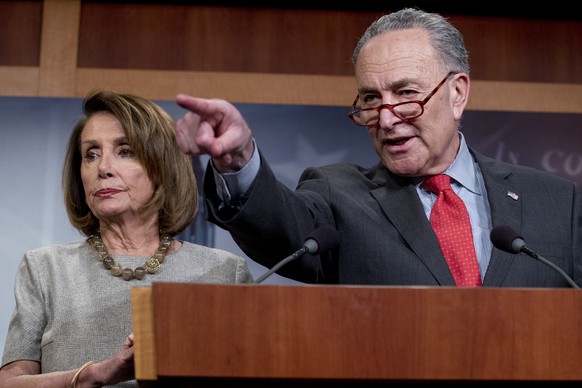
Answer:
[271, 135, 348, 188]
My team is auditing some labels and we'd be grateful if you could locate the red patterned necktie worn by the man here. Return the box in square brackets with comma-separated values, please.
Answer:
[422, 175, 481, 287]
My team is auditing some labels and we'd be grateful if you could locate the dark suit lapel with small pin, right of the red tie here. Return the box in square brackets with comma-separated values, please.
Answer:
[472, 151, 522, 287]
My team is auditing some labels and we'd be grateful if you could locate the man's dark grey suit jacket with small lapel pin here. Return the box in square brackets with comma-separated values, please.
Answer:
[204, 150, 582, 287]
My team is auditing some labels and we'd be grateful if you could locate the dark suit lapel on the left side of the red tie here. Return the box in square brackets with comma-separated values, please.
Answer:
[371, 168, 455, 286]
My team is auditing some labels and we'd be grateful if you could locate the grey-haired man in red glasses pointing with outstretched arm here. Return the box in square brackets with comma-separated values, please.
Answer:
[177, 9, 582, 287]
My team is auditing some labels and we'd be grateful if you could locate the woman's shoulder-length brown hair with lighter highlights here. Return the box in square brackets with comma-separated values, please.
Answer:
[62, 91, 198, 236]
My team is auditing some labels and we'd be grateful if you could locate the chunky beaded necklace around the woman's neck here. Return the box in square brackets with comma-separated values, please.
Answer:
[88, 233, 172, 280]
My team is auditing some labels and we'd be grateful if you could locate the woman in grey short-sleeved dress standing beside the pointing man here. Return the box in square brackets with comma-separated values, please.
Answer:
[0, 91, 253, 388]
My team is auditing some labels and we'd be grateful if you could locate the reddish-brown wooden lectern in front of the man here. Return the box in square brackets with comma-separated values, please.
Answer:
[131, 283, 582, 387]
